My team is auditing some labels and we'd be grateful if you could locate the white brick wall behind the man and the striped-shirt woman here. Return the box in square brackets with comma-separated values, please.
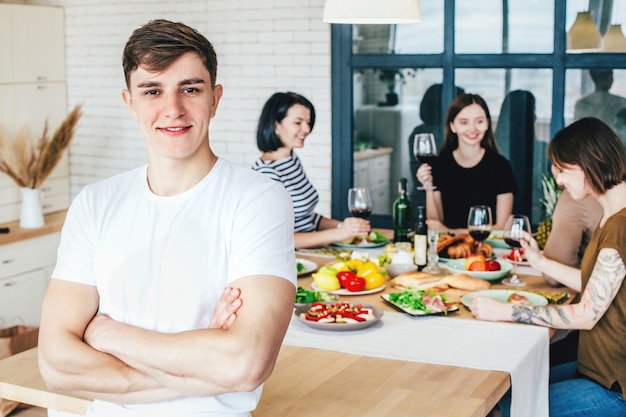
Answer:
[15, 0, 331, 215]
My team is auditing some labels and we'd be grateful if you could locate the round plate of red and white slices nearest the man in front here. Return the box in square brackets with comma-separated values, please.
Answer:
[293, 302, 383, 331]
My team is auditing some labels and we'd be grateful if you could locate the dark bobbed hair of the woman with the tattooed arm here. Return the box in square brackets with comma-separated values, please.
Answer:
[548, 117, 626, 194]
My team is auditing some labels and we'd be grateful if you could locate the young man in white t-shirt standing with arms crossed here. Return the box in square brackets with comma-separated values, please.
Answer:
[39, 20, 296, 417]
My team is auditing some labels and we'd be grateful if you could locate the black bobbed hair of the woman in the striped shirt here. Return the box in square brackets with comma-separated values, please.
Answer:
[256, 91, 315, 152]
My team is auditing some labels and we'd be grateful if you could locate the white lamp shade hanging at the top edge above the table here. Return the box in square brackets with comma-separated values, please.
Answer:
[323, 0, 422, 24]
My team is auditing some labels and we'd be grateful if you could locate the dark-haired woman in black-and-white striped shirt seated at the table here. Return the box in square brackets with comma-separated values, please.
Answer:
[252, 92, 370, 249]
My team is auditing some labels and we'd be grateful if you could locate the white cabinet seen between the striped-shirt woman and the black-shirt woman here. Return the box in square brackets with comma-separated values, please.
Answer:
[354, 148, 393, 214]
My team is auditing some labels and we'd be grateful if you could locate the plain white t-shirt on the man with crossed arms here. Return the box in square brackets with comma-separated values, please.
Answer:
[52, 159, 296, 417]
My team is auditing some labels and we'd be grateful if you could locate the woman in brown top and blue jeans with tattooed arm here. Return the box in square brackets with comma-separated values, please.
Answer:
[471, 118, 626, 417]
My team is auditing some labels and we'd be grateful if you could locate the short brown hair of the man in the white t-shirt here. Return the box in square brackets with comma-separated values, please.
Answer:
[122, 19, 217, 87]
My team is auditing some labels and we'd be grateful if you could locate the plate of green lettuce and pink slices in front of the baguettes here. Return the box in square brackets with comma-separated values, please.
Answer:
[381, 288, 459, 316]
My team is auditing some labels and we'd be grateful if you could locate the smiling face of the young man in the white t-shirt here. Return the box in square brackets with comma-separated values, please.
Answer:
[122, 53, 222, 161]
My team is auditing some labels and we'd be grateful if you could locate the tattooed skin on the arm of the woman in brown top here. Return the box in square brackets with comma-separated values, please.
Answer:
[511, 248, 626, 328]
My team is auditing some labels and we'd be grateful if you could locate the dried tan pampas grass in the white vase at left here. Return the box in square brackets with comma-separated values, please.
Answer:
[0, 105, 82, 188]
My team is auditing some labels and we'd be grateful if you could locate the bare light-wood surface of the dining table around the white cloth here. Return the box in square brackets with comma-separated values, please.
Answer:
[0, 242, 574, 417]
